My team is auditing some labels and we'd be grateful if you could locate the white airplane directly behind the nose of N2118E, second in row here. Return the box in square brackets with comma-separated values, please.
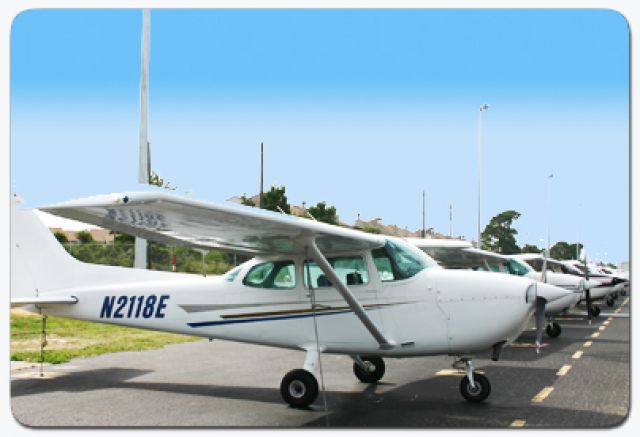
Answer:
[407, 238, 584, 338]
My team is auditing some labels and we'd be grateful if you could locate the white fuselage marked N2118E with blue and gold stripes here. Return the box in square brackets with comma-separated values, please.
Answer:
[33, 245, 536, 356]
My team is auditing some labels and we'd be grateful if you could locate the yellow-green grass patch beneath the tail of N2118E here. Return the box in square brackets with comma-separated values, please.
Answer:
[11, 310, 201, 364]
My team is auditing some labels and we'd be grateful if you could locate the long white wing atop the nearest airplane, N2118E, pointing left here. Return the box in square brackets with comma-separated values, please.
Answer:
[41, 192, 385, 255]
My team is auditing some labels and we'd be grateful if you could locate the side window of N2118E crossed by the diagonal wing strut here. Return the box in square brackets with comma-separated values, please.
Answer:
[302, 256, 369, 288]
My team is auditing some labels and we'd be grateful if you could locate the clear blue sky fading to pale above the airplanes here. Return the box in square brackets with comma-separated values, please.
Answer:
[11, 10, 629, 262]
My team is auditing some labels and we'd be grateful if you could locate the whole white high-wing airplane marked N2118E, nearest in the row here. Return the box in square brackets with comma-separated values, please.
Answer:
[11, 192, 563, 407]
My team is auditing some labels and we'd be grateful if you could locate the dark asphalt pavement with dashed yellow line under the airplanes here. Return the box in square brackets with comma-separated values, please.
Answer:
[11, 297, 630, 428]
